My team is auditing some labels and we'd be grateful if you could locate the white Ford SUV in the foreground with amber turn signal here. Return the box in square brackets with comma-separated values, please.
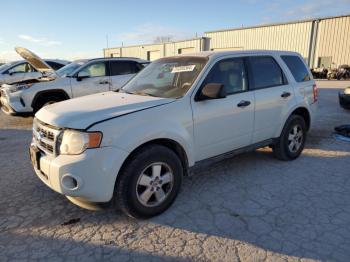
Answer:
[30, 51, 317, 218]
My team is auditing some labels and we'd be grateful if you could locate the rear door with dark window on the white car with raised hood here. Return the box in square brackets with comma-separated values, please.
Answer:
[107, 60, 143, 90]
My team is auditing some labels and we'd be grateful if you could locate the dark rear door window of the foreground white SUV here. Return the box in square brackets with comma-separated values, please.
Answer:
[249, 56, 287, 89]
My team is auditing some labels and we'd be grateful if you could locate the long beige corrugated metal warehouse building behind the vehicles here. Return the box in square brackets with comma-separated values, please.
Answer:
[104, 15, 350, 67]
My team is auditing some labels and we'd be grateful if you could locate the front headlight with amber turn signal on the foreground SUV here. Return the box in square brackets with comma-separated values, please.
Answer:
[58, 130, 102, 155]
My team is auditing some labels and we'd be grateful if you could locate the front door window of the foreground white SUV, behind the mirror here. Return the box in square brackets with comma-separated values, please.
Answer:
[204, 58, 248, 95]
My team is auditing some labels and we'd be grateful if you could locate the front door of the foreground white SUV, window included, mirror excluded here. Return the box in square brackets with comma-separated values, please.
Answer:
[192, 58, 254, 161]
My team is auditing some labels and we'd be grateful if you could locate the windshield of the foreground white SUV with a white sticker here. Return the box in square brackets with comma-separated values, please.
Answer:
[122, 56, 208, 98]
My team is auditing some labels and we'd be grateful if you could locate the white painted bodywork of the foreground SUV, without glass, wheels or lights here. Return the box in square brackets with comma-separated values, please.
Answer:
[29, 51, 317, 202]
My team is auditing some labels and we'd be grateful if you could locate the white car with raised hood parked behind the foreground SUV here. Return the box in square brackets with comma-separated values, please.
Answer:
[0, 48, 149, 114]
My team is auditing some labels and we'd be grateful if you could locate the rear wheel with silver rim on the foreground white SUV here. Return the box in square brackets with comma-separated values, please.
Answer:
[273, 115, 307, 161]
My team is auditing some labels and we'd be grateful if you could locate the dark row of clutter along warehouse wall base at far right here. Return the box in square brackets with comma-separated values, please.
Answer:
[311, 65, 350, 80]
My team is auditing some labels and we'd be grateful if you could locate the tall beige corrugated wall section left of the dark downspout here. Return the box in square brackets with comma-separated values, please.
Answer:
[205, 21, 312, 58]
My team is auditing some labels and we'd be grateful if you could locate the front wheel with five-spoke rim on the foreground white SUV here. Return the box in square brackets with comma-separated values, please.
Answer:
[114, 145, 183, 218]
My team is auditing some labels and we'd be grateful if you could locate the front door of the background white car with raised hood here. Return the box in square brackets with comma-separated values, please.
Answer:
[71, 61, 111, 97]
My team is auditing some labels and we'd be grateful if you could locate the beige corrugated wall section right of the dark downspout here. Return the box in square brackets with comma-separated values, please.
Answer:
[313, 16, 350, 67]
